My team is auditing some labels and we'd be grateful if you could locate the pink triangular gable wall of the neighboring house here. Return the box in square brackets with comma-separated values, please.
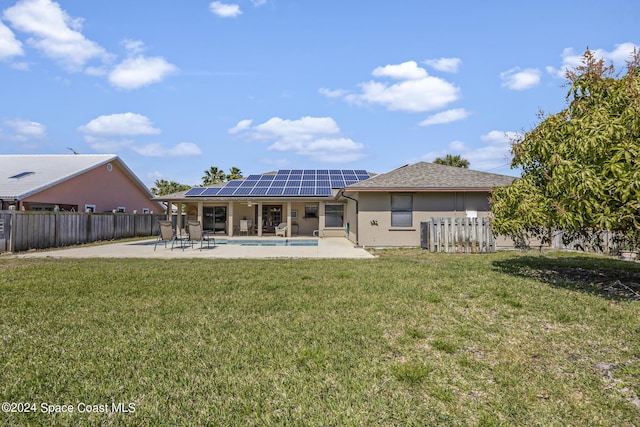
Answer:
[23, 162, 162, 213]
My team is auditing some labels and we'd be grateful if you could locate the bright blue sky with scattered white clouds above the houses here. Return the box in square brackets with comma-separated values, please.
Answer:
[0, 0, 640, 186]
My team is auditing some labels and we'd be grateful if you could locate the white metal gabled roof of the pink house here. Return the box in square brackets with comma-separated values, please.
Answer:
[0, 154, 152, 200]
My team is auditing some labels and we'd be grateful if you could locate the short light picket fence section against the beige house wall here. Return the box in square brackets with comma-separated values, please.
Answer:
[420, 217, 496, 253]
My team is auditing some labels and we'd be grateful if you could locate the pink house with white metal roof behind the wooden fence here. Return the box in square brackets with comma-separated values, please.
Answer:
[0, 154, 164, 213]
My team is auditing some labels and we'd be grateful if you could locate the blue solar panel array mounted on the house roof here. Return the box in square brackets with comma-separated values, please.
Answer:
[185, 169, 369, 197]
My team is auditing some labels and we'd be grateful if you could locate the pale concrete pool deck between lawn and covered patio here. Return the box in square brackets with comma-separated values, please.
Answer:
[10, 237, 375, 259]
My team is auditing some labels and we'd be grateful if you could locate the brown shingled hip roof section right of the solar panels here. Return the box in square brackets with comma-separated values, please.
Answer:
[345, 162, 516, 192]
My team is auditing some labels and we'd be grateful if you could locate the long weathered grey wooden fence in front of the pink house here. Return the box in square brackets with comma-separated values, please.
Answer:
[0, 211, 166, 252]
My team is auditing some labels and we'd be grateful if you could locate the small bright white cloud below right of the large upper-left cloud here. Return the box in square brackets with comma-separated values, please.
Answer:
[109, 56, 177, 89]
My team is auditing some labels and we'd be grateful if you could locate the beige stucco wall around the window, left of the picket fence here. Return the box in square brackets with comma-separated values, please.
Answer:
[352, 192, 490, 247]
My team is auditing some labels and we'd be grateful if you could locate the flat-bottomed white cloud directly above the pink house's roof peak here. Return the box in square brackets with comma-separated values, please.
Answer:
[78, 113, 160, 136]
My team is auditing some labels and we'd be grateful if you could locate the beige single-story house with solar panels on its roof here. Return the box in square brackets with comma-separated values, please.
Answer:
[156, 162, 515, 246]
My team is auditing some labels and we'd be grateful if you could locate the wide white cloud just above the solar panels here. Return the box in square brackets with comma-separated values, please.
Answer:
[230, 117, 364, 163]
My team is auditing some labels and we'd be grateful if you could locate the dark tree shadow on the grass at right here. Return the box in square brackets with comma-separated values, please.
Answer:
[493, 255, 640, 300]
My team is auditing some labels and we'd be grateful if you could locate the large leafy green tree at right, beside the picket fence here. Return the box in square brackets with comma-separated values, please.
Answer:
[492, 50, 640, 249]
